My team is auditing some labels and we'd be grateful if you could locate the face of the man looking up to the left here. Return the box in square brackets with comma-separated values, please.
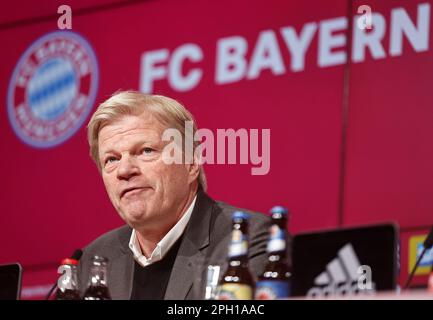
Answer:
[98, 112, 198, 231]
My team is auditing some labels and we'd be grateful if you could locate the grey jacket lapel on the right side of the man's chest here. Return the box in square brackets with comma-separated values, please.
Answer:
[165, 191, 214, 300]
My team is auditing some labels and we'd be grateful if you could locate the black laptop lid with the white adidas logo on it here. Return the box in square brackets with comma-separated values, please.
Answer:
[292, 224, 398, 297]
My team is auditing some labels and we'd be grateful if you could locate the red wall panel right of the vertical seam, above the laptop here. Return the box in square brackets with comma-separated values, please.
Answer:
[344, 1, 433, 229]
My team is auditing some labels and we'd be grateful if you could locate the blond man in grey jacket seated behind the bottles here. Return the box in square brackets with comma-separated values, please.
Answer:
[80, 91, 270, 299]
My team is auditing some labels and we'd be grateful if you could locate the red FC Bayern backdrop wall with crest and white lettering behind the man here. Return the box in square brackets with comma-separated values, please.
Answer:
[0, 0, 433, 298]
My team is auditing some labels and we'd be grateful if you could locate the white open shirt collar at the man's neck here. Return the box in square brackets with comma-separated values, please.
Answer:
[129, 196, 197, 267]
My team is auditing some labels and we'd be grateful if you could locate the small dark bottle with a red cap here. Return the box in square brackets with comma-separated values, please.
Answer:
[56, 258, 81, 300]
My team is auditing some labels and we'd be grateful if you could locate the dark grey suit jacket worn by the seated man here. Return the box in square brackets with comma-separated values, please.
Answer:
[80, 191, 284, 299]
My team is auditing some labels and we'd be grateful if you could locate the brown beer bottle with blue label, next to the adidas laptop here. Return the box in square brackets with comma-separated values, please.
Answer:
[255, 206, 292, 300]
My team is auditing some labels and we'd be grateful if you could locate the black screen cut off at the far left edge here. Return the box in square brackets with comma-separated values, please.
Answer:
[0, 263, 22, 300]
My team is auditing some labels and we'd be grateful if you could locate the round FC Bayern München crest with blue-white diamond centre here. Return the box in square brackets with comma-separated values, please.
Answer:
[7, 31, 99, 148]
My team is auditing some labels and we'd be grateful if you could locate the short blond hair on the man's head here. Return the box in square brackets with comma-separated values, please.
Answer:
[87, 90, 207, 190]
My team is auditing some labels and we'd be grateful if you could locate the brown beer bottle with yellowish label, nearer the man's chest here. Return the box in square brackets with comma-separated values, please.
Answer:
[217, 211, 254, 300]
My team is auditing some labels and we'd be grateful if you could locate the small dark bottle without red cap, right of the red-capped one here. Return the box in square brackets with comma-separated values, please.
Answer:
[84, 256, 111, 300]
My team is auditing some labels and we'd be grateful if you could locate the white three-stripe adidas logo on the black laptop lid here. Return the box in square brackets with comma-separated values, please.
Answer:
[307, 243, 376, 298]
